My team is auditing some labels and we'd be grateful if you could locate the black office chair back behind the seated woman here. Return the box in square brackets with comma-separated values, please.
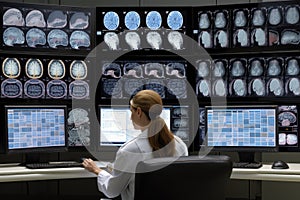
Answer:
[134, 155, 232, 200]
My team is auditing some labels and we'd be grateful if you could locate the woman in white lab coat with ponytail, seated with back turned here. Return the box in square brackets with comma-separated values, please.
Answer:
[83, 90, 188, 200]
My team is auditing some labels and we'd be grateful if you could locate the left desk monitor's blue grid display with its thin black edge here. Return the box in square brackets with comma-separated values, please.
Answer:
[5, 105, 67, 152]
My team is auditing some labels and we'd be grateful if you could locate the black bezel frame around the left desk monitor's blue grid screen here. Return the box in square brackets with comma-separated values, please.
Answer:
[4, 105, 68, 154]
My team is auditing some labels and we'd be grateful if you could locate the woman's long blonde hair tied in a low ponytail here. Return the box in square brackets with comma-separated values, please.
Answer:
[132, 90, 175, 157]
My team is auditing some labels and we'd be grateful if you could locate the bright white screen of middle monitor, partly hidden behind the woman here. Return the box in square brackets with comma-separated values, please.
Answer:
[99, 105, 171, 146]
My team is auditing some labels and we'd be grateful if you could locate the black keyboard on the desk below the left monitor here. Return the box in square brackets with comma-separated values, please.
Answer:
[25, 161, 83, 169]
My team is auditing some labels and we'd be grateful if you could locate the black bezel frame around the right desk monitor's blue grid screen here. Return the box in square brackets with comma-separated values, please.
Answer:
[205, 105, 278, 153]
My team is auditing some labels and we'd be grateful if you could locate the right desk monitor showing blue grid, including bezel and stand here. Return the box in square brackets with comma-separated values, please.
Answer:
[205, 105, 278, 162]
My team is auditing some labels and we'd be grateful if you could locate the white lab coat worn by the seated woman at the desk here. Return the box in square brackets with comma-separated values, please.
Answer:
[97, 130, 188, 200]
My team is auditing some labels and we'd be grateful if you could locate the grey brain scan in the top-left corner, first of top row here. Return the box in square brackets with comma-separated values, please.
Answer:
[3, 8, 25, 26]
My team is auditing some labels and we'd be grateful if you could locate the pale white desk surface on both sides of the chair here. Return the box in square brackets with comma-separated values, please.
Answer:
[0, 162, 300, 182]
